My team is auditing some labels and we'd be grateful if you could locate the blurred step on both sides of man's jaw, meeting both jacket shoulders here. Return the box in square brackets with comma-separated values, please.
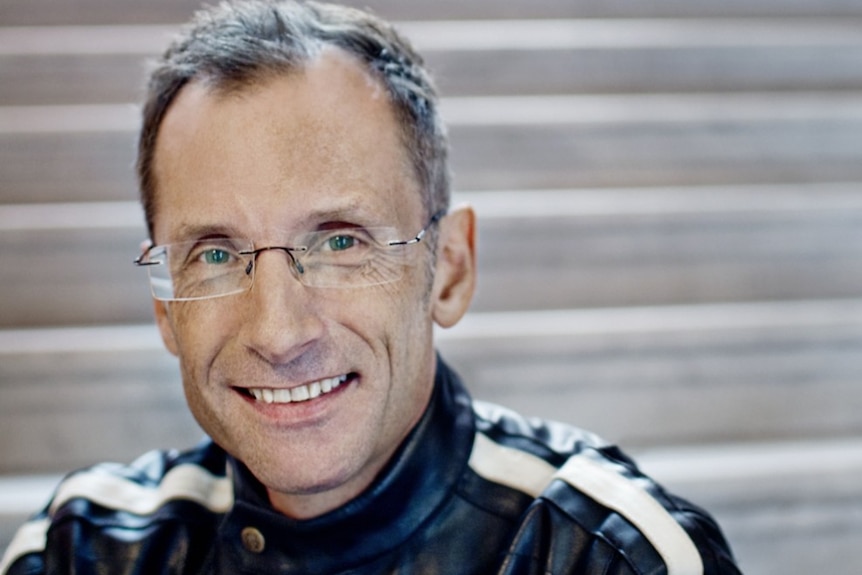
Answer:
[0, 300, 862, 473]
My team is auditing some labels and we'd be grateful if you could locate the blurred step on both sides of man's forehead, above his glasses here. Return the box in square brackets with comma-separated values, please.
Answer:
[0, 92, 862, 203]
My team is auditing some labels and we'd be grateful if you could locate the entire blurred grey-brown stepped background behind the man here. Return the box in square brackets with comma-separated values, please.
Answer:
[0, 0, 862, 575]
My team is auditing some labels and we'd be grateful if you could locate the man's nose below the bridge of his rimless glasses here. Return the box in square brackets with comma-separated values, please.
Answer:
[241, 249, 324, 365]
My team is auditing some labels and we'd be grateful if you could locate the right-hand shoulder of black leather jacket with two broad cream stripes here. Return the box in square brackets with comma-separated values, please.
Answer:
[470, 402, 738, 575]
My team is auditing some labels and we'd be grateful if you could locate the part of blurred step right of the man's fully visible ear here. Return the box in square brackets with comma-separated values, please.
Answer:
[470, 184, 862, 311]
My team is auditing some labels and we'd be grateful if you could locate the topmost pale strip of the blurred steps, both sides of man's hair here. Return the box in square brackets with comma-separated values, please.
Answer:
[6, 18, 862, 56]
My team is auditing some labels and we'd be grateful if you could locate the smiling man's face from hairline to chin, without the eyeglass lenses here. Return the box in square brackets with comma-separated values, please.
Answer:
[154, 50, 446, 517]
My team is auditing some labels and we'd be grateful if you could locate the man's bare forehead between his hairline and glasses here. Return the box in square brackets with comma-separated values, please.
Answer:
[154, 49, 422, 242]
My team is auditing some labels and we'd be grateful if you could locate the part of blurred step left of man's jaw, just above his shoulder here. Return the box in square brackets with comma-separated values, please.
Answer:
[0, 325, 203, 473]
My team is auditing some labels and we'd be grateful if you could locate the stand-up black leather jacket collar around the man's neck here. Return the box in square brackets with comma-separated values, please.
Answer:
[221, 358, 474, 573]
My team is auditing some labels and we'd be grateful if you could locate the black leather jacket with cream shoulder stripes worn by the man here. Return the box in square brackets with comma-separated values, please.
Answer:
[0, 362, 739, 575]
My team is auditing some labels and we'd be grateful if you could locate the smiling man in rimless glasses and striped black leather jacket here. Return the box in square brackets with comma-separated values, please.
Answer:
[3, 1, 738, 575]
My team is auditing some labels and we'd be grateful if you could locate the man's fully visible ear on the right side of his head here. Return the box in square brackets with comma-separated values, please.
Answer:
[431, 206, 476, 327]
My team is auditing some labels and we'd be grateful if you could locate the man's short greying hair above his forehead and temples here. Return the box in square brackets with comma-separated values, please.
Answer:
[137, 0, 451, 237]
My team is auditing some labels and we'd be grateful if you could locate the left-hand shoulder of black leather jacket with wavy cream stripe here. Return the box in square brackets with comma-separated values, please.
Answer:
[0, 441, 233, 575]
